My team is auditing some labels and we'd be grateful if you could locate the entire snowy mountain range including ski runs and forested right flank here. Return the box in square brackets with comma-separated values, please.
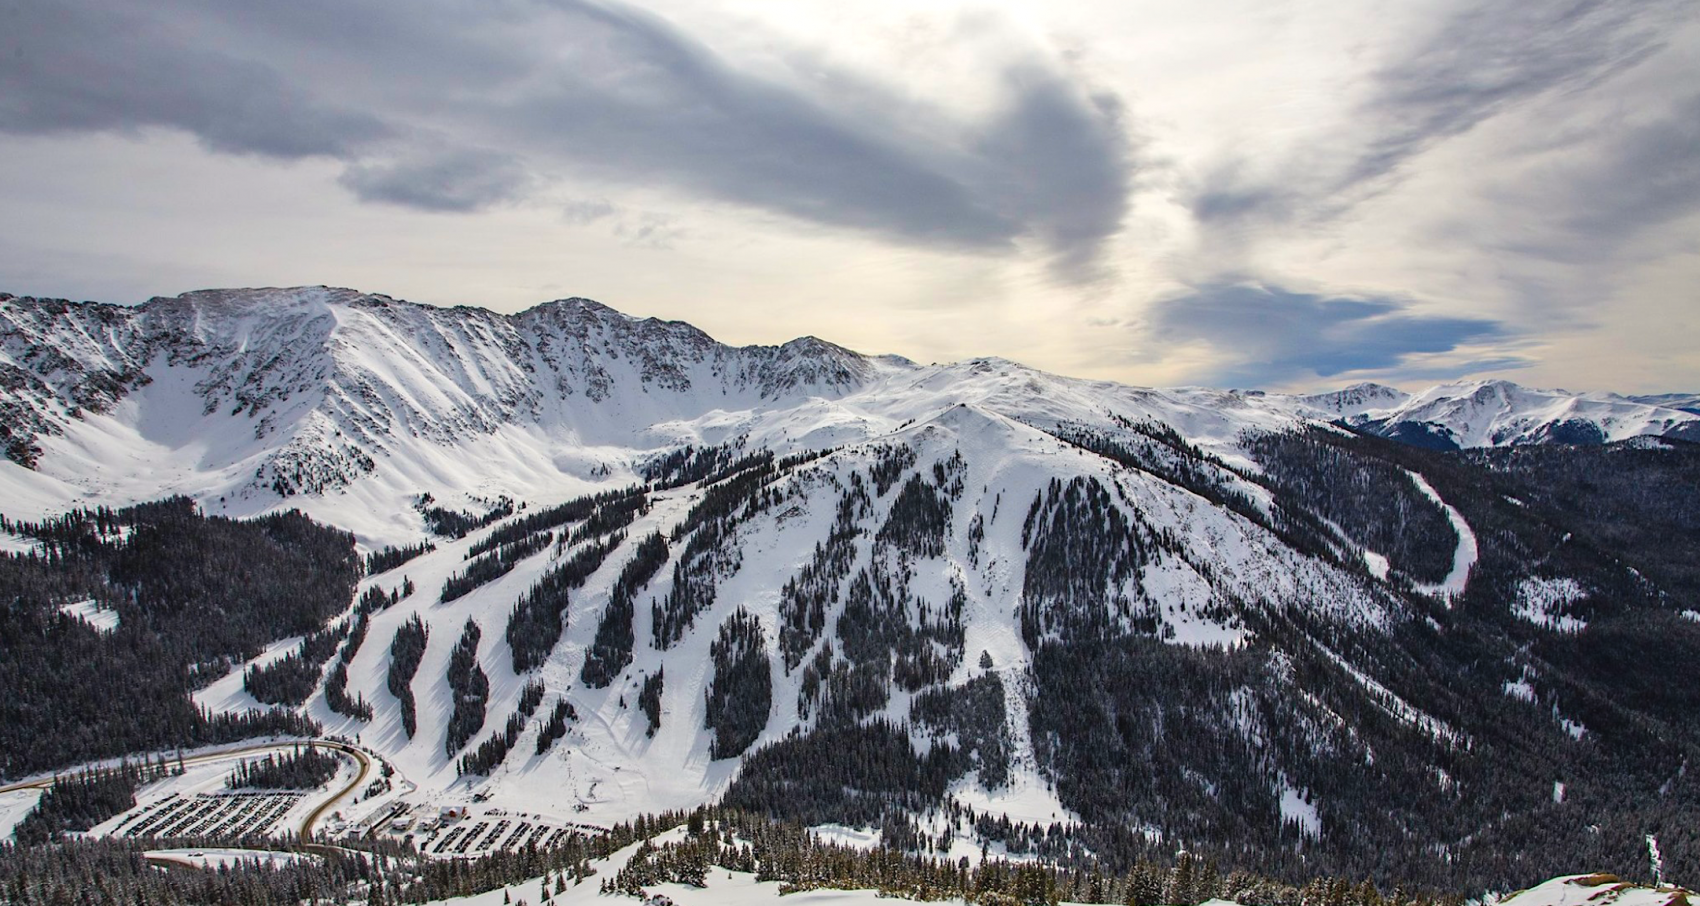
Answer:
[0, 287, 1700, 886]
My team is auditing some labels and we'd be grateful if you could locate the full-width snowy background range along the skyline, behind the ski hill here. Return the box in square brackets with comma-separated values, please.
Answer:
[0, 287, 1700, 544]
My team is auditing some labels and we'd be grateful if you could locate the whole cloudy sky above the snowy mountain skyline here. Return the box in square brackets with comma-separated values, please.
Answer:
[0, 0, 1700, 391]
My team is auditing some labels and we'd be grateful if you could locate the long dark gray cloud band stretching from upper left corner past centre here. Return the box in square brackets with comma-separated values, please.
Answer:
[0, 0, 1134, 280]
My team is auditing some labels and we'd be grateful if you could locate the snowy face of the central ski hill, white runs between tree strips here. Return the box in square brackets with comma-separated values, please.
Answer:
[182, 405, 1407, 823]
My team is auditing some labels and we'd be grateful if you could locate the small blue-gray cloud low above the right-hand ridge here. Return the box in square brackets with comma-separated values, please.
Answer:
[1151, 284, 1513, 386]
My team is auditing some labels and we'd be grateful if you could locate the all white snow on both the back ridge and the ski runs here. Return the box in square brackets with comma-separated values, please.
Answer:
[16, 287, 1672, 863]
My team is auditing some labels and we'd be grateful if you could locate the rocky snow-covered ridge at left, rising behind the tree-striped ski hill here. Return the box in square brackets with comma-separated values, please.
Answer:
[0, 287, 911, 535]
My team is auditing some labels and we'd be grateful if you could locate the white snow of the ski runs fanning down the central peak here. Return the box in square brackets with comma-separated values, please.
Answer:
[142, 396, 1399, 832]
